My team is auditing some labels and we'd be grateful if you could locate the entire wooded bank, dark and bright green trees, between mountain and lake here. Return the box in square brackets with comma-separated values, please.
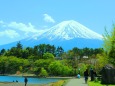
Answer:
[0, 42, 103, 76]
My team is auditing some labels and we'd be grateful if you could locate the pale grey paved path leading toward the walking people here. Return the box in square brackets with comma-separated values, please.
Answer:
[65, 78, 88, 86]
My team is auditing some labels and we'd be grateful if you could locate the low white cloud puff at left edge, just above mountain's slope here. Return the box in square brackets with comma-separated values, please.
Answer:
[0, 29, 20, 38]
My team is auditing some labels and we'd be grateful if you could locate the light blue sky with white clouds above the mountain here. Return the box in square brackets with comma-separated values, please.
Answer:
[0, 0, 115, 45]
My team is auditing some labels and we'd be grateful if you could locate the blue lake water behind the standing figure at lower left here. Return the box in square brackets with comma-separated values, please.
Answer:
[0, 76, 61, 84]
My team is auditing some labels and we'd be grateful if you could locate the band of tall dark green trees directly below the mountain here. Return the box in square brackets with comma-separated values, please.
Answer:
[0, 42, 103, 60]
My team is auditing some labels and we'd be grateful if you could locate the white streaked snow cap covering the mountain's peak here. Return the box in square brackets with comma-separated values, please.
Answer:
[42, 20, 102, 40]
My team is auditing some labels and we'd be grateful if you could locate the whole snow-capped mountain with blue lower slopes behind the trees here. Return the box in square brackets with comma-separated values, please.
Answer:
[0, 20, 103, 50]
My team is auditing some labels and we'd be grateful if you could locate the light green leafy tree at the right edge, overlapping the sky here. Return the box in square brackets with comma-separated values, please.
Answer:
[104, 25, 115, 65]
